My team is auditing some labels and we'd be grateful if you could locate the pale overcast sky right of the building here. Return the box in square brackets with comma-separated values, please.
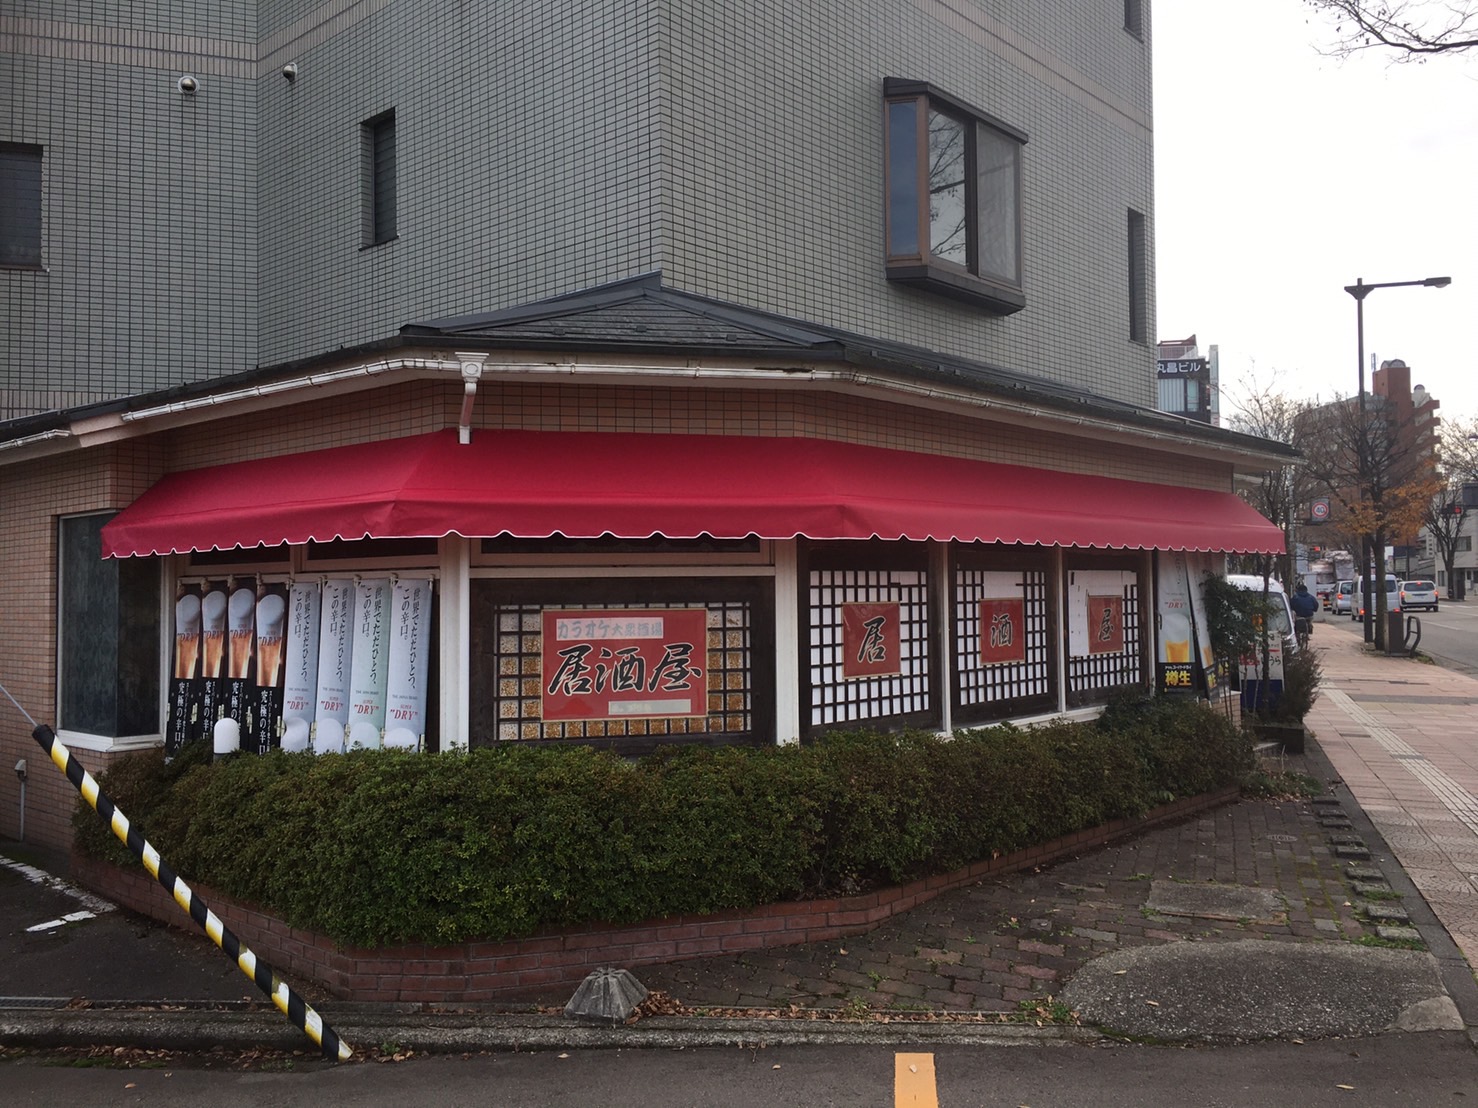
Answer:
[1151, 0, 1478, 420]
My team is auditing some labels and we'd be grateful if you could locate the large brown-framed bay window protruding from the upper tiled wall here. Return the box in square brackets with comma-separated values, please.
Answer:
[884, 77, 1027, 315]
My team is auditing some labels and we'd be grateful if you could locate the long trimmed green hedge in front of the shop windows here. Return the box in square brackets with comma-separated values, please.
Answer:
[74, 697, 1252, 945]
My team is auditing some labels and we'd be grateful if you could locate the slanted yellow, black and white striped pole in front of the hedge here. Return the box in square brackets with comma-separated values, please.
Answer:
[27, 720, 353, 1062]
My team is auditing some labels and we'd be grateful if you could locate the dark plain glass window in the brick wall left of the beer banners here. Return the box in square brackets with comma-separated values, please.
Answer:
[56, 513, 160, 739]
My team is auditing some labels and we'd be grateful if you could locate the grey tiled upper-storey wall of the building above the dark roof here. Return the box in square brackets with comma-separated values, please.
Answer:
[0, 0, 1154, 417]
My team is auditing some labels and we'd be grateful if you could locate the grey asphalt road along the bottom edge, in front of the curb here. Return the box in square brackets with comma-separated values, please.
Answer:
[0, 1033, 1478, 1108]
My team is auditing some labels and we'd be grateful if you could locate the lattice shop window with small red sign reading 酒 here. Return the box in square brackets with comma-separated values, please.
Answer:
[950, 547, 1057, 724]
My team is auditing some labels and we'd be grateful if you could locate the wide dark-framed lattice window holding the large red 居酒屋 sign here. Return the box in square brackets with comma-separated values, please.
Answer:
[469, 578, 774, 753]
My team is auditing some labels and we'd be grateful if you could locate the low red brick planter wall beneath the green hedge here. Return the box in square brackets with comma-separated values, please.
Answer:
[72, 787, 1239, 1005]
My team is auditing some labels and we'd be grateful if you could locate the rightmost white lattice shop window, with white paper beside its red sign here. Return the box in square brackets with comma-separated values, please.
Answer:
[1063, 557, 1145, 708]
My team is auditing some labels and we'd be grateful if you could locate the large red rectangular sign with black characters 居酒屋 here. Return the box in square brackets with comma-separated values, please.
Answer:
[539, 607, 708, 722]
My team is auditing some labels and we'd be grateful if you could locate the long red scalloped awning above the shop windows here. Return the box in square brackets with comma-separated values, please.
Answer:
[103, 430, 1283, 555]
